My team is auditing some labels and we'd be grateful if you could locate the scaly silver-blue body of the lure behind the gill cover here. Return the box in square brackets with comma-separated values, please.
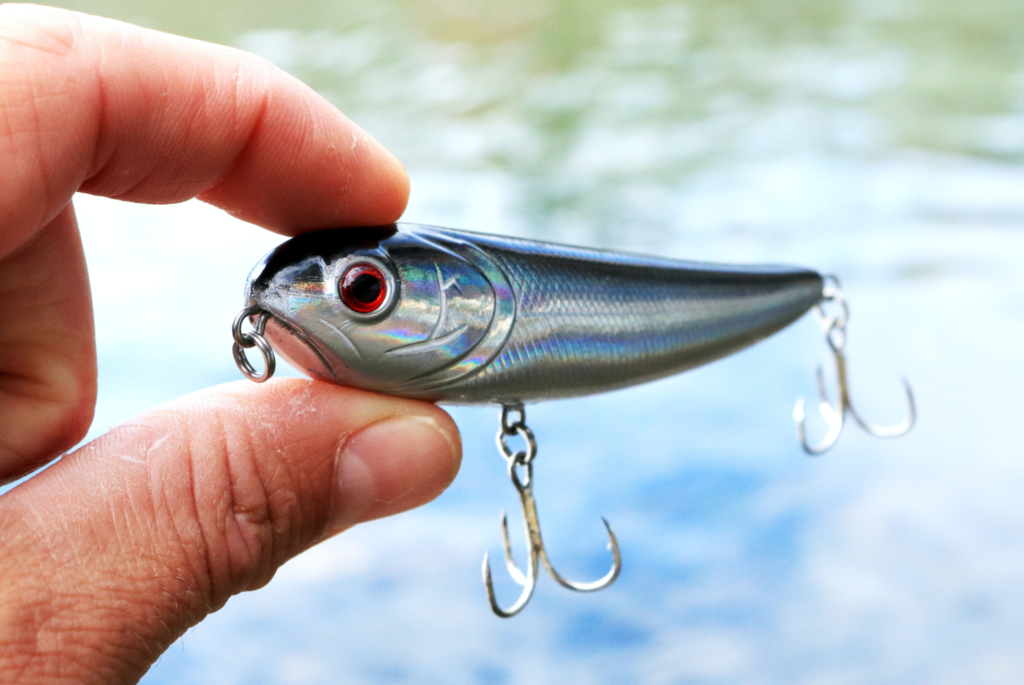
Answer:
[409, 231, 822, 402]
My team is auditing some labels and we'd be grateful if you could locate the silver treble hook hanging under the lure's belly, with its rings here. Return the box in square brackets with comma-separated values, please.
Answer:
[483, 402, 623, 618]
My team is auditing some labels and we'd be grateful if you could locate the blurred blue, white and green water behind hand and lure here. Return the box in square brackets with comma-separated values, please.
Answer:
[44, 0, 1024, 685]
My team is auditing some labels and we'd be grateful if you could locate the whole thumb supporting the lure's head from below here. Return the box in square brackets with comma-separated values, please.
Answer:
[0, 379, 461, 683]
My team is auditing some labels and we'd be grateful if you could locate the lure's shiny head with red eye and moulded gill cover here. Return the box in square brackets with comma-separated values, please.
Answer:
[246, 226, 501, 398]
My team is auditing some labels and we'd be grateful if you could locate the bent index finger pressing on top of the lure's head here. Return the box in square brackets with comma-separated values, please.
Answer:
[0, 4, 409, 258]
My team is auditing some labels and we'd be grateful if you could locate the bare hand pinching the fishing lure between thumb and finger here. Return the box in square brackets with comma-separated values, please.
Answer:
[0, 4, 462, 683]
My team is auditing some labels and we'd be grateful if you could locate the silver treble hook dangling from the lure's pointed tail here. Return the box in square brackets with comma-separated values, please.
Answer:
[793, 275, 918, 457]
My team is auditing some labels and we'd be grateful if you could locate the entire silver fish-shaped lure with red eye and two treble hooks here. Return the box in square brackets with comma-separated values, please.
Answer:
[232, 224, 915, 617]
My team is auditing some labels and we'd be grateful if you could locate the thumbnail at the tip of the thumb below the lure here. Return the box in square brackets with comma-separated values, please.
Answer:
[330, 416, 461, 533]
